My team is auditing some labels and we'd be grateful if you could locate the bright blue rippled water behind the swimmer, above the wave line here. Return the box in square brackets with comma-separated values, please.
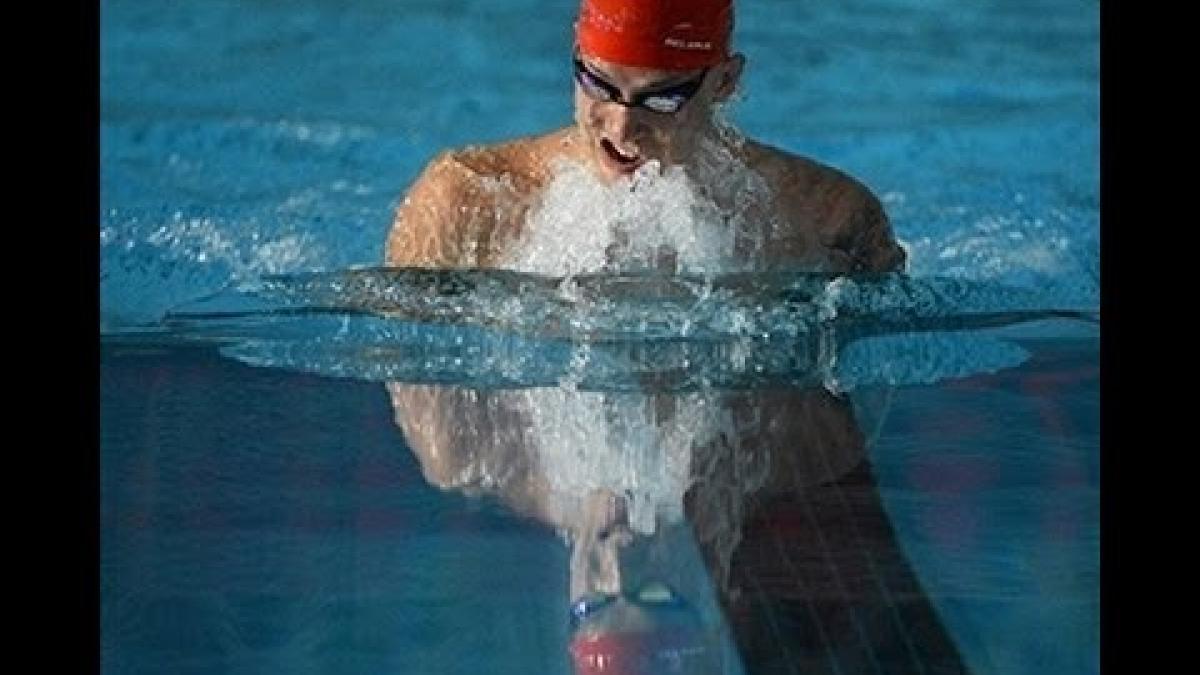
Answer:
[100, 0, 1099, 325]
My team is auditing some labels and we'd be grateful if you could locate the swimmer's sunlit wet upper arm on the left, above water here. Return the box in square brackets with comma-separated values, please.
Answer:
[384, 153, 473, 267]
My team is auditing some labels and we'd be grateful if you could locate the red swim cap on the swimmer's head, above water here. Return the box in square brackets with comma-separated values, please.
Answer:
[575, 0, 733, 71]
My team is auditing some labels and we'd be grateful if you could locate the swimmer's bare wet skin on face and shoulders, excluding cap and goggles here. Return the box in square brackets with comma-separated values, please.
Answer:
[384, 49, 905, 274]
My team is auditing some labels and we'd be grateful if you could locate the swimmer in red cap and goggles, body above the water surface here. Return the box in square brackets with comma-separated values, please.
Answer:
[385, 0, 905, 274]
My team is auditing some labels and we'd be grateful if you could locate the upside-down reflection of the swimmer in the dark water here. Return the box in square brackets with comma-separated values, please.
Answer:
[386, 381, 965, 673]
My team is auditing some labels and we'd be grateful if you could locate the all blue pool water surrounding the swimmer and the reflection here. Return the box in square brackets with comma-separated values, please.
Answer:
[98, 0, 1100, 674]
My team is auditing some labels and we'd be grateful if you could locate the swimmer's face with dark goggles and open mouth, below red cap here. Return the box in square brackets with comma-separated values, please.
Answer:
[575, 54, 743, 180]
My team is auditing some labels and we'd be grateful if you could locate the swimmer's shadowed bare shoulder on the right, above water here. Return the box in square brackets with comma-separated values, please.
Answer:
[745, 141, 906, 273]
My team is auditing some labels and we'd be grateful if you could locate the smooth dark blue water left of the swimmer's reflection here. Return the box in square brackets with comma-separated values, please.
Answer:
[101, 345, 576, 673]
